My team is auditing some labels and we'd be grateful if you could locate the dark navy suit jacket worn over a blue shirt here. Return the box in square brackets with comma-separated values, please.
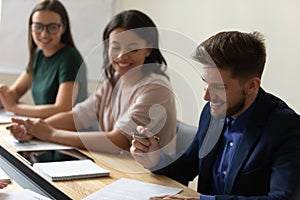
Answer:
[155, 89, 300, 200]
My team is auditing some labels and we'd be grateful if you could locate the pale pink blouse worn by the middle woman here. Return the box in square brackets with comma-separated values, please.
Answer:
[73, 69, 176, 153]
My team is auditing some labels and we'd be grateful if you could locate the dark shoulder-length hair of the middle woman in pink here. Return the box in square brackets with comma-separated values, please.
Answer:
[102, 10, 167, 85]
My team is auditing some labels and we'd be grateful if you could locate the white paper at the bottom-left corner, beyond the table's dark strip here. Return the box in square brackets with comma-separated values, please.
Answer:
[0, 186, 51, 200]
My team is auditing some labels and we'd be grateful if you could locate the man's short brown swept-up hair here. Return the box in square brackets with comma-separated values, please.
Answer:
[194, 31, 266, 80]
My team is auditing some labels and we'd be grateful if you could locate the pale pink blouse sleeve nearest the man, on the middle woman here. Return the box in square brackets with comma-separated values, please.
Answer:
[115, 77, 176, 152]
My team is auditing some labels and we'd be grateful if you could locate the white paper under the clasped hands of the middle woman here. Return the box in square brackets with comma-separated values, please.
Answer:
[3, 136, 74, 151]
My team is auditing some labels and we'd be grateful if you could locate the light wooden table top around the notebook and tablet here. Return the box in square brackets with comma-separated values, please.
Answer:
[0, 125, 198, 200]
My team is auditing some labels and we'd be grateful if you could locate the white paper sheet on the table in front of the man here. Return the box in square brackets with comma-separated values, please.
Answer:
[84, 178, 182, 200]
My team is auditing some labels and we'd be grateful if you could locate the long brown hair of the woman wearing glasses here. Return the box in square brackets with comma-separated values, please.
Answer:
[28, 0, 75, 73]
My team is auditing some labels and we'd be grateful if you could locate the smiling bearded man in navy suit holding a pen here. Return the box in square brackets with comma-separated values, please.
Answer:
[130, 31, 300, 200]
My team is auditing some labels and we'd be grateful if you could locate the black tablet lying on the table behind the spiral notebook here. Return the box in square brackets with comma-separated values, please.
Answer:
[17, 149, 93, 165]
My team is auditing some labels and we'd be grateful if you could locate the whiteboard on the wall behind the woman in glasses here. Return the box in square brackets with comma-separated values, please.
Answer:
[0, 0, 118, 81]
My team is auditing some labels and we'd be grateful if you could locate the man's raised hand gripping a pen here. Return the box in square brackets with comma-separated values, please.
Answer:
[130, 126, 160, 168]
